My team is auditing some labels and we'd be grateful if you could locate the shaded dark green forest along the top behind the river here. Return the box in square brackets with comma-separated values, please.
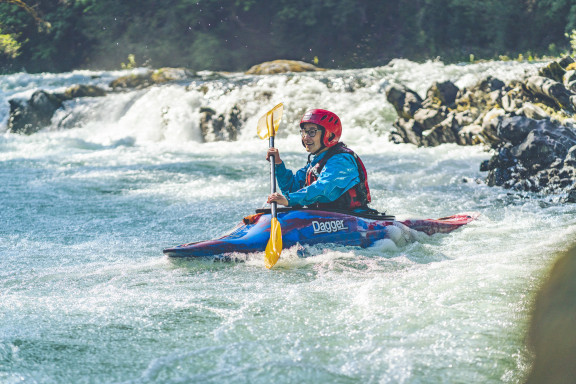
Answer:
[0, 0, 576, 72]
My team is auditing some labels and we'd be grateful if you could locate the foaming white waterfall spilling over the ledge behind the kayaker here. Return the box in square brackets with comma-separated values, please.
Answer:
[0, 60, 537, 143]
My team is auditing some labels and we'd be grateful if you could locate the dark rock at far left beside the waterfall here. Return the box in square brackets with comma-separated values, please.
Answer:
[8, 90, 62, 135]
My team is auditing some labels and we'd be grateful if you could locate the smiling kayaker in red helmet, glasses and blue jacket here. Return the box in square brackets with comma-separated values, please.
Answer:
[266, 109, 371, 211]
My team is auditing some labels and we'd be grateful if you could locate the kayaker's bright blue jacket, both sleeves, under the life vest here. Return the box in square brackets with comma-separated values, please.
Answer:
[276, 152, 360, 206]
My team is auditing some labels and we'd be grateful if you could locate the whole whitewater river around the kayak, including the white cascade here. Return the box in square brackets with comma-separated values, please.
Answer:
[0, 60, 576, 383]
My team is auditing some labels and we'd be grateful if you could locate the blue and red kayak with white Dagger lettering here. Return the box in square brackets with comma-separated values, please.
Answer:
[164, 208, 479, 257]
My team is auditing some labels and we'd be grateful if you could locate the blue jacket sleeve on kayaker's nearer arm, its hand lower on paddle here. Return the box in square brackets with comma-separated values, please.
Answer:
[282, 153, 360, 206]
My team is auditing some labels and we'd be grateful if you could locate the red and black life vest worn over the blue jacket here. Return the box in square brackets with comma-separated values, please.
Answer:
[305, 143, 372, 209]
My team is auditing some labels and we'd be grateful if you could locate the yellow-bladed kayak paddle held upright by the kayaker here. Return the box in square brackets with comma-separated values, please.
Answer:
[258, 103, 284, 269]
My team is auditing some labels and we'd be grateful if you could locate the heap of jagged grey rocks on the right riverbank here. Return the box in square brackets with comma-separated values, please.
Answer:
[386, 58, 576, 202]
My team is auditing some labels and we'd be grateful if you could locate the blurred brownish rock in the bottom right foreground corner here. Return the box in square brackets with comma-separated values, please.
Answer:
[525, 247, 576, 384]
